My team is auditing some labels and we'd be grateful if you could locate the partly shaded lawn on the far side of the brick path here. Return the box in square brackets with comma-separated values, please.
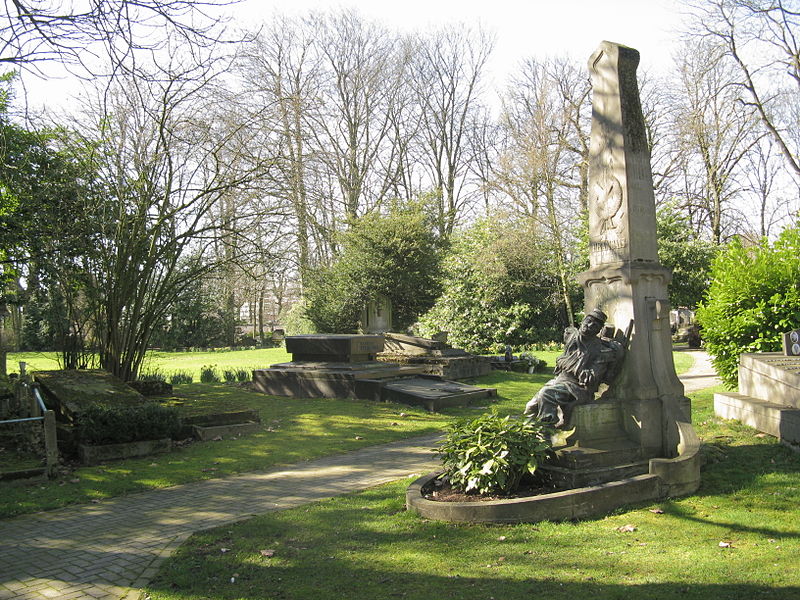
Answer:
[0, 350, 692, 518]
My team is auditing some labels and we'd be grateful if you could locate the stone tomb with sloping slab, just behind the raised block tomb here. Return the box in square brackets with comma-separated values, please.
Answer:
[377, 333, 492, 379]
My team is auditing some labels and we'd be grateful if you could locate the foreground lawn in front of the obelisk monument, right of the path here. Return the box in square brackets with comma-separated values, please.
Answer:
[147, 390, 800, 600]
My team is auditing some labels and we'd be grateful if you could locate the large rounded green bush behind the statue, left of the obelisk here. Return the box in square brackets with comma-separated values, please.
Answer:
[419, 216, 581, 353]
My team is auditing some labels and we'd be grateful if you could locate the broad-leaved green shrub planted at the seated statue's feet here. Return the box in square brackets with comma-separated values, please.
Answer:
[437, 412, 551, 494]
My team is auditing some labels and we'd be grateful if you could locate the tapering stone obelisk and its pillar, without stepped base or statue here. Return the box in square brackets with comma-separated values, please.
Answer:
[579, 42, 689, 457]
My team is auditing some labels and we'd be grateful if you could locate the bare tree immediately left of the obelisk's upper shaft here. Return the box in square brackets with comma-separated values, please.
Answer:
[494, 59, 590, 322]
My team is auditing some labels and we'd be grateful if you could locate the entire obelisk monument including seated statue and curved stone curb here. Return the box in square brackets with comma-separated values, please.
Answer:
[406, 42, 700, 523]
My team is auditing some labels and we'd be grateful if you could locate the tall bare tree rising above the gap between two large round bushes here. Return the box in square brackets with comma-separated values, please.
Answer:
[411, 27, 494, 237]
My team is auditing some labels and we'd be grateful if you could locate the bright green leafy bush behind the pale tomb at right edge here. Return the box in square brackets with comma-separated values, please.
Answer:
[697, 228, 800, 387]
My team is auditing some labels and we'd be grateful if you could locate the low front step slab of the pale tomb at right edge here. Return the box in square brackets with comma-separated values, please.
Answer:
[714, 392, 800, 446]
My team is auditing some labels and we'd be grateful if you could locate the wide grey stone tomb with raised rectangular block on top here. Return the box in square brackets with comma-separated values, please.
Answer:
[253, 334, 497, 411]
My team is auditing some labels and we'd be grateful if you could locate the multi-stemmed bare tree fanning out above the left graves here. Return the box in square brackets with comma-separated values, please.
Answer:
[58, 53, 264, 380]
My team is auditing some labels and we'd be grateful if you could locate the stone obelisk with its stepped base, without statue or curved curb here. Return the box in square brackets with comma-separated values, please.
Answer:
[553, 42, 699, 493]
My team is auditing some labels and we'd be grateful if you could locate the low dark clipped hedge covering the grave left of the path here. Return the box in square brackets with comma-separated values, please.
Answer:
[77, 402, 180, 444]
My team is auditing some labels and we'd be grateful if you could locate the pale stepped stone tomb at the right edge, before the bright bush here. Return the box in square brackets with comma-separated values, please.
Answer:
[714, 352, 800, 450]
